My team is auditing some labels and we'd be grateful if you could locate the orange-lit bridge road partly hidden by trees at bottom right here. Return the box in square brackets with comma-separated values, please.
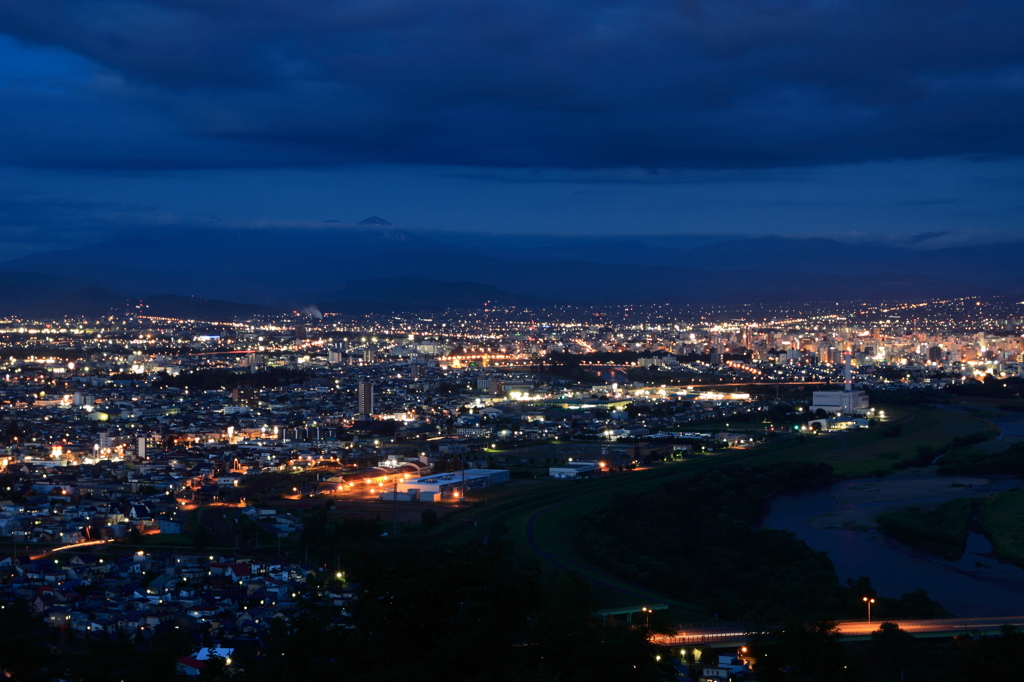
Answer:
[650, 615, 1024, 647]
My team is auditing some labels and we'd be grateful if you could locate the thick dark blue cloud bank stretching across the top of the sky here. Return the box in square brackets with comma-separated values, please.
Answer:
[0, 0, 1024, 168]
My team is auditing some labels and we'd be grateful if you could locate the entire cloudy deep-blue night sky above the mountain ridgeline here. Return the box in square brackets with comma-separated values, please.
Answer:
[0, 0, 1024, 259]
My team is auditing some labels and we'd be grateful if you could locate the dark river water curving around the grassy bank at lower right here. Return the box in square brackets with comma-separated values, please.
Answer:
[762, 473, 1024, 616]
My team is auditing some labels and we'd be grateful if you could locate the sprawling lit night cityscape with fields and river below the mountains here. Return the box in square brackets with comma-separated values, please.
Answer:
[0, 296, 1024, 682]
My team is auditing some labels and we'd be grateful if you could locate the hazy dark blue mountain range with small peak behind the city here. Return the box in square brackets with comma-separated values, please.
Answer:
[0, 224, 1024, 319]
